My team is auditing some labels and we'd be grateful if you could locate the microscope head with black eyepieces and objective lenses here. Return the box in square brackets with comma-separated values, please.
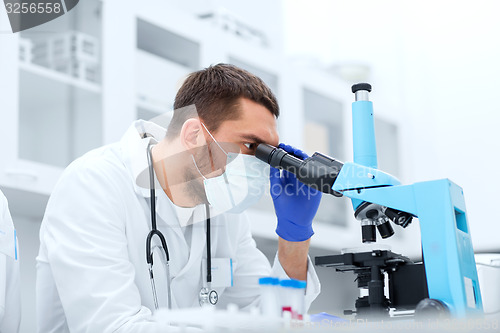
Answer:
[255, 144, 414, 237]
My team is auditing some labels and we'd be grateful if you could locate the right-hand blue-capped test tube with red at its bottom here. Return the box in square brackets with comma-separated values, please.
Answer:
[280, 279, 306, 320]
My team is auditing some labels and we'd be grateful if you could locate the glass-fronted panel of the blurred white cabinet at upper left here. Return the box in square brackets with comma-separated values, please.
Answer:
[18, 0, 103, 169]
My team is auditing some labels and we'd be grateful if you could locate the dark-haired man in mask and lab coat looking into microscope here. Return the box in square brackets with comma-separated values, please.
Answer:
[37, 64, 321, 332]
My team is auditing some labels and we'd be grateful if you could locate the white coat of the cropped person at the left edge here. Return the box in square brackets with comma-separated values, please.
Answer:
[0, 191, 21, 333]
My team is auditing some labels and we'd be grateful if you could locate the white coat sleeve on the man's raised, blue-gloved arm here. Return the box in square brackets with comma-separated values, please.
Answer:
[219, 214, 320, 310]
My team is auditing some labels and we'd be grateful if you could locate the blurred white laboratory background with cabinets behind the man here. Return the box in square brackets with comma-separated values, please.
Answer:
[0, 0, 500, 332]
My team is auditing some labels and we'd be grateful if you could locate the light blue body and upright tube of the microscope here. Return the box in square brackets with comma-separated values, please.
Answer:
[332, 84, 483, 317]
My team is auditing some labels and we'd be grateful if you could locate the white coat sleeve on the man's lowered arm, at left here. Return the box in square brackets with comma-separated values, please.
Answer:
[41, 160, 191, 333]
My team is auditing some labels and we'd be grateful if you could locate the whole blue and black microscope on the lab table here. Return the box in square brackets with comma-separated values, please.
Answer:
[255, 83, 483, 318]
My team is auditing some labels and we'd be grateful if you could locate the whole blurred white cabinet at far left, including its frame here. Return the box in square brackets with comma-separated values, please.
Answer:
[0, 0, 102, 202]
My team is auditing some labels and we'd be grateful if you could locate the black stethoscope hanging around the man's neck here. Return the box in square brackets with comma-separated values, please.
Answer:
[146, 143, 219, 310]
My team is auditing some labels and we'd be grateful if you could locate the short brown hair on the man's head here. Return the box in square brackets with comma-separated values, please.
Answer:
[167, 64, 280, 138]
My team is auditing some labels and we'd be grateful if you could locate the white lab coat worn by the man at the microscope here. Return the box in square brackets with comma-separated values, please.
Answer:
[37, 121, 320, 333]
